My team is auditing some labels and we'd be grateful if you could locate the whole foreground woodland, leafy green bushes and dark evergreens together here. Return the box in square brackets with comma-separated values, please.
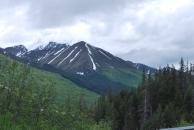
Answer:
[0, 55, 194, 130]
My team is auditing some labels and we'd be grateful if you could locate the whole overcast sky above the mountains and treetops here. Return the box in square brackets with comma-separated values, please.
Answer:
[0, 0, 194, 67]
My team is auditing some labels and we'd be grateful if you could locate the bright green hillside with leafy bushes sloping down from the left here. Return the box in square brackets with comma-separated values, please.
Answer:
[0, 55, 110, 130]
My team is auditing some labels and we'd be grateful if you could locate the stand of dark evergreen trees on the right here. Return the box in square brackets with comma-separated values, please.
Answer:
[94, 59, 194, 130]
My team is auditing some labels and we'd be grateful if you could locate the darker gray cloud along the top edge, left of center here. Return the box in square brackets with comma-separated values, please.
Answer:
[26, 0, 130, 28]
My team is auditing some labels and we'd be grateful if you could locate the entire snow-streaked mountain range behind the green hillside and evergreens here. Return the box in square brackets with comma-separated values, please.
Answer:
[0, 41, 156, 93]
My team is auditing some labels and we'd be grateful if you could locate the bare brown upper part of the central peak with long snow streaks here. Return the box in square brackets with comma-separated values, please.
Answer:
[32, 41, 135, 73]
